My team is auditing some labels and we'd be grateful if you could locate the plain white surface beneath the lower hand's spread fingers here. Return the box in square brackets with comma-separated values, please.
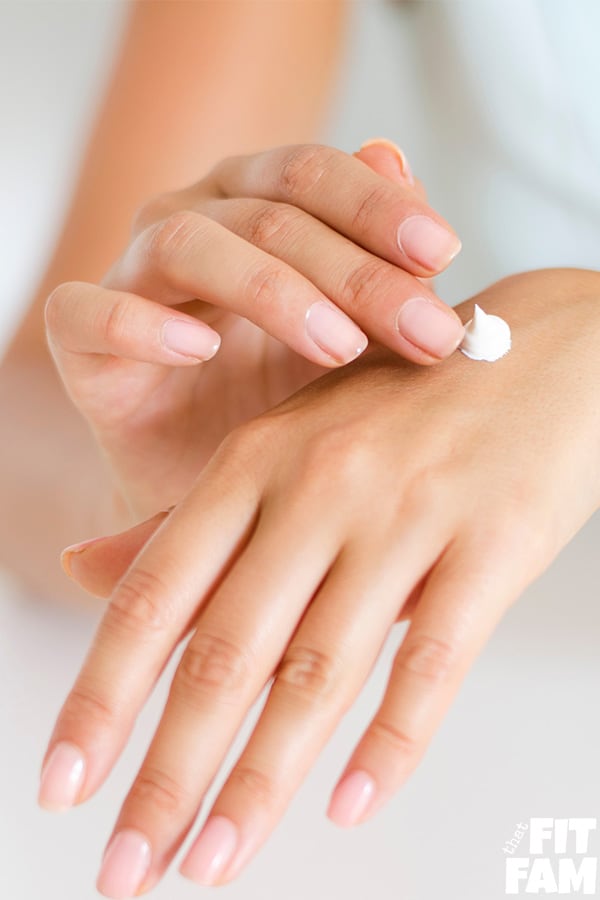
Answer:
[0, 516, 600, 900]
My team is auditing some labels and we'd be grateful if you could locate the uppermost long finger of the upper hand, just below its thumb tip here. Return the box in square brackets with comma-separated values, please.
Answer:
[209, 144, 461, 276]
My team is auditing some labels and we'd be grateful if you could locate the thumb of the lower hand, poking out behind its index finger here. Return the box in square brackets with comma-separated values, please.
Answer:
[60, 506, 174, 597]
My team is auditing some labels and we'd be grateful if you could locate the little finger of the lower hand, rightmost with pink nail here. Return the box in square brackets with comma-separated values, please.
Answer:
[327, 520, 535, 826]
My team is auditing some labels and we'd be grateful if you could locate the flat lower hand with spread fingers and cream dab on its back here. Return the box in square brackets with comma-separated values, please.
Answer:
[41, 269, 600, 896]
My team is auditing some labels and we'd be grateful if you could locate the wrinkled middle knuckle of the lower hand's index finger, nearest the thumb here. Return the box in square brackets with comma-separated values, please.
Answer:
[109, 567, 175, 634]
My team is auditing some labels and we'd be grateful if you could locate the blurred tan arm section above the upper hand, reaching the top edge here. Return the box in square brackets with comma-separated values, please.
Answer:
[16, 0, 345, 352]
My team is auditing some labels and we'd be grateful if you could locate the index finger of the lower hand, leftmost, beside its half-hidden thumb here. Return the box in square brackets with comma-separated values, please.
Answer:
[39, 439, 258, 809]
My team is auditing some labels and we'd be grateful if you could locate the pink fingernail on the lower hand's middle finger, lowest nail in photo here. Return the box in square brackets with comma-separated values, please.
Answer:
[96, 828, 152, 900]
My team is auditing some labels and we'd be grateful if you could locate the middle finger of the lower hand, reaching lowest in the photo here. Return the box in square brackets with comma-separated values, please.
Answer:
[98, 478, 343, 896]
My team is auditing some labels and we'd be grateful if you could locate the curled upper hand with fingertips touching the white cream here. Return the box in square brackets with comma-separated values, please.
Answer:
[45, 145, 463, 524]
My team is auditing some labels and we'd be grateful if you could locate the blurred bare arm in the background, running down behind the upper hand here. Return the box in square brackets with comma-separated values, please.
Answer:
[0, 0, 344, 600]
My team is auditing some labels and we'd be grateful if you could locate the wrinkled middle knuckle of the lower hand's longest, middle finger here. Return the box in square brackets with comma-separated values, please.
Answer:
[173, 631, 251, 704]
